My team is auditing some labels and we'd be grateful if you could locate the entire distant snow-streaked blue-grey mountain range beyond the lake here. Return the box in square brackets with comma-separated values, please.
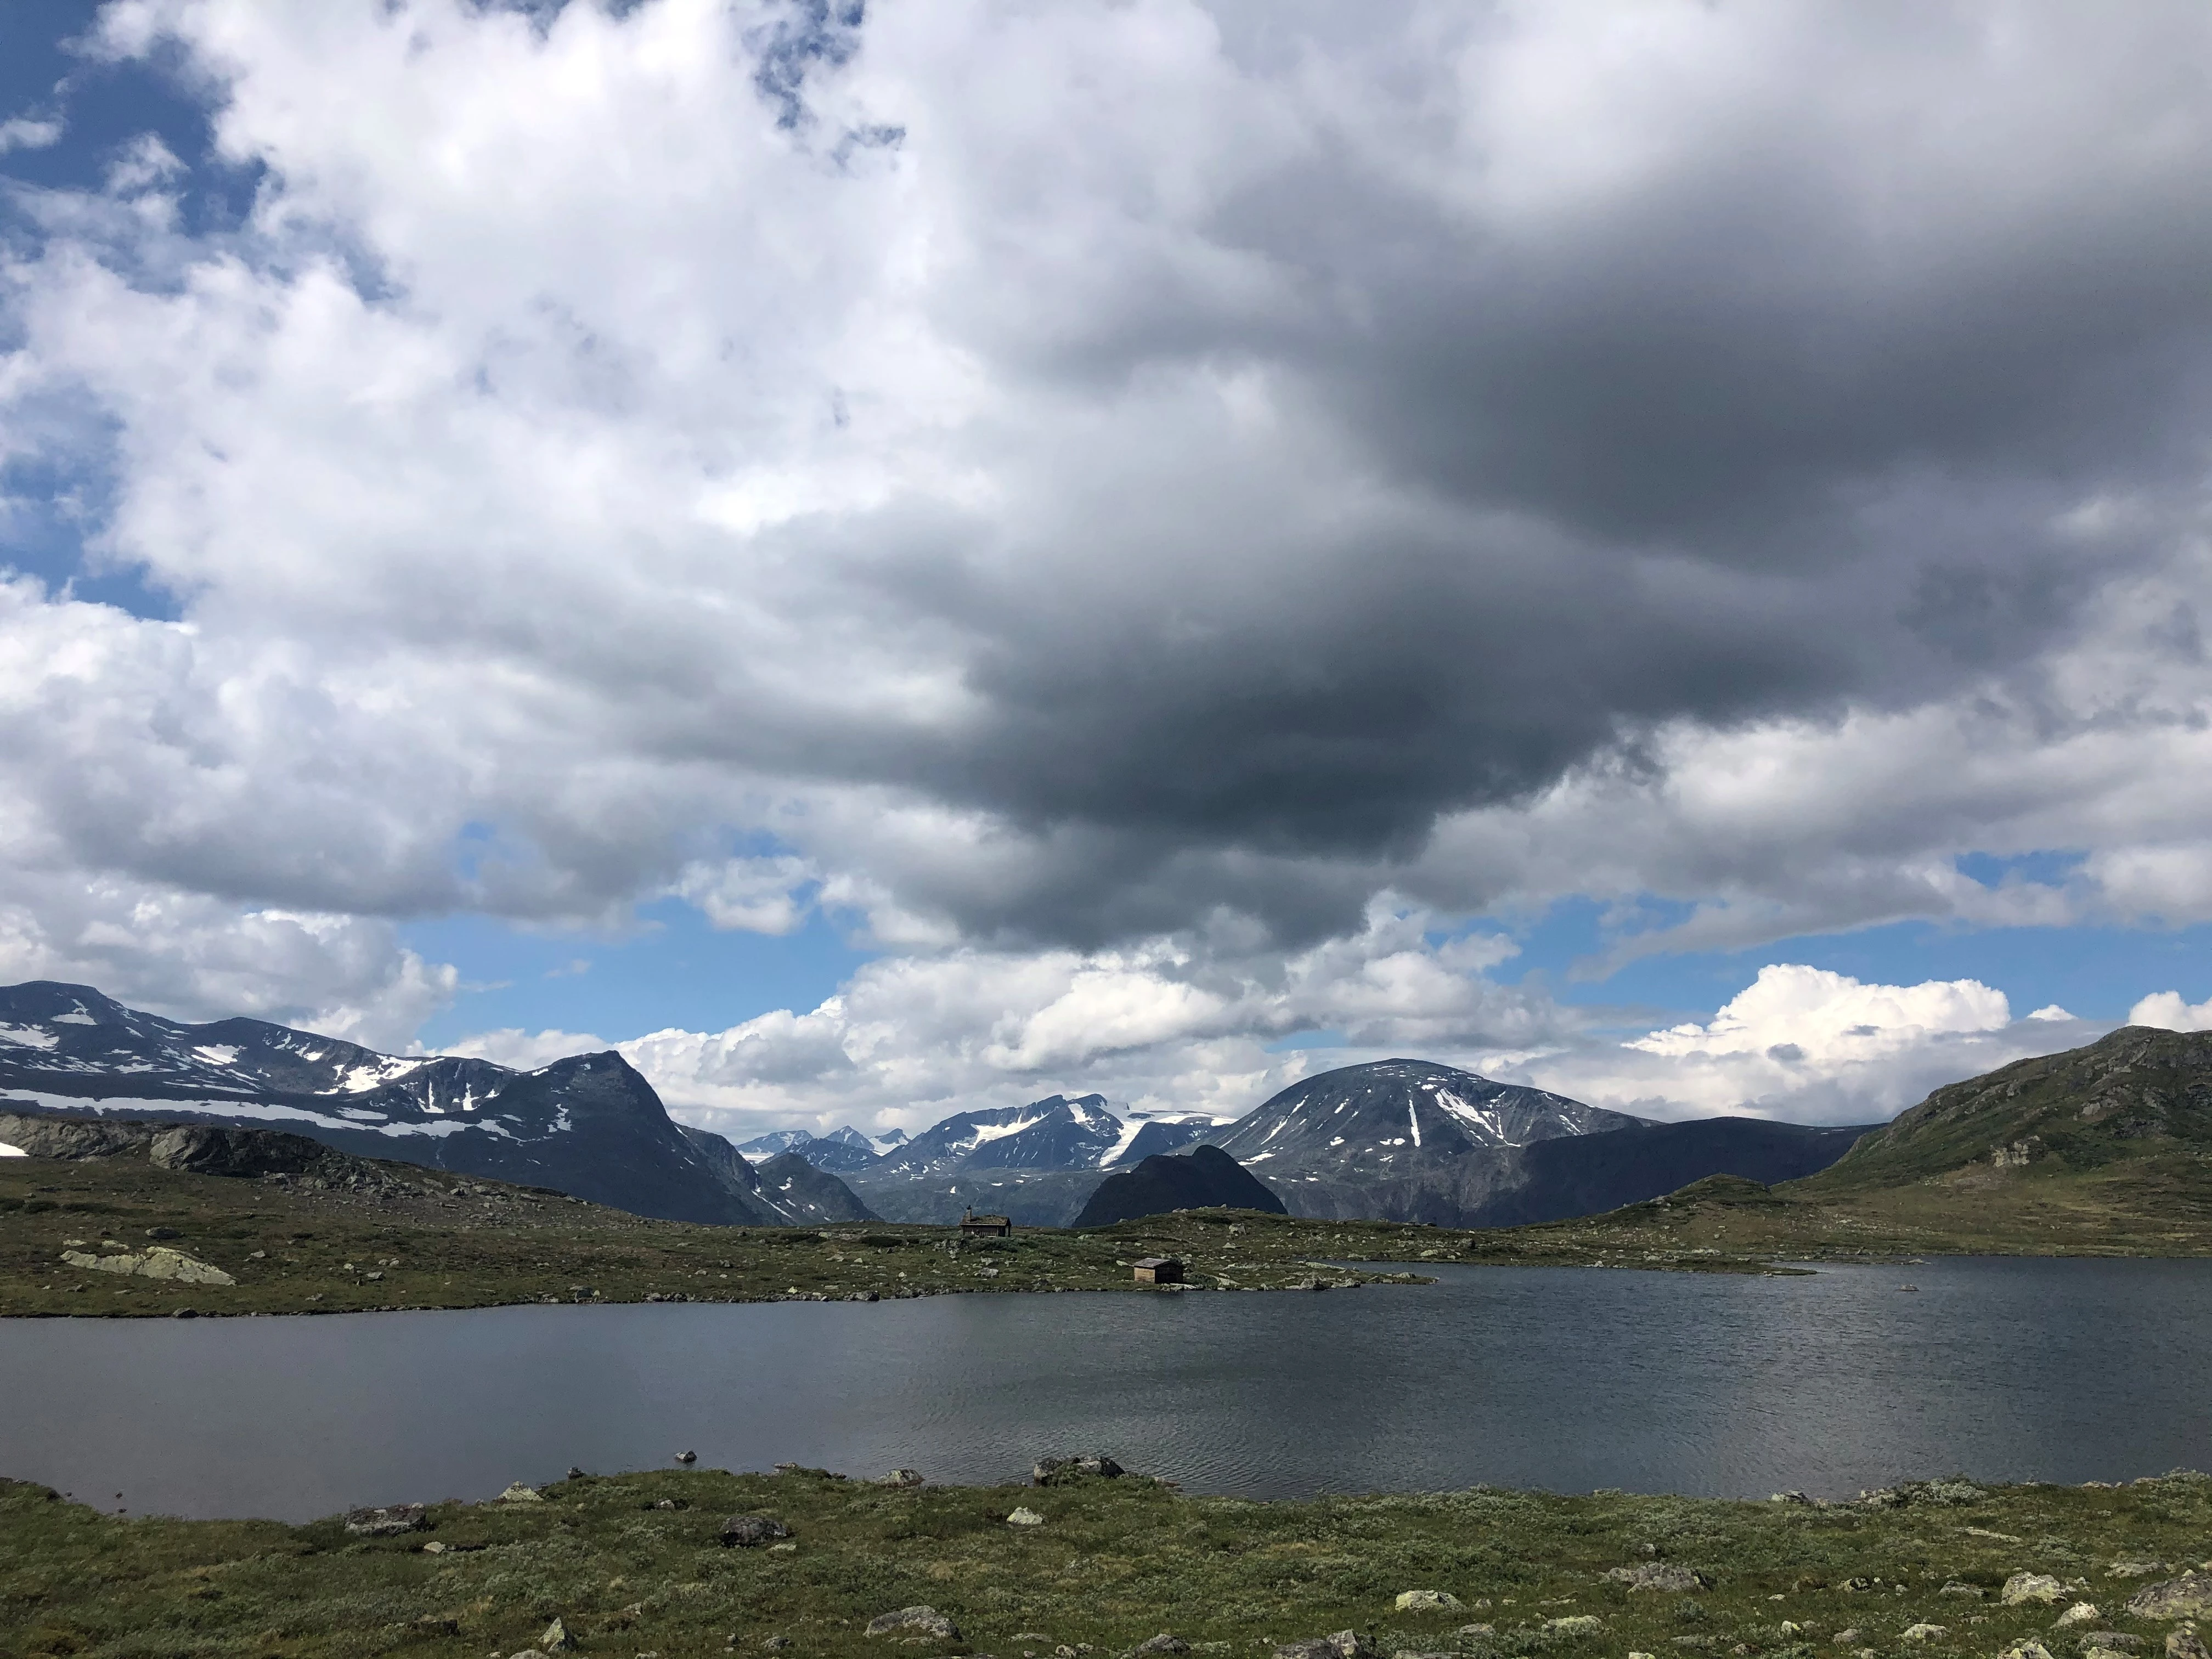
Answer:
[0, 982, 1860, 1226]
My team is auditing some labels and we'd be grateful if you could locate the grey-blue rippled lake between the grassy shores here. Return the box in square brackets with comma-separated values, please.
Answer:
[0, 1261, 2212, 1520]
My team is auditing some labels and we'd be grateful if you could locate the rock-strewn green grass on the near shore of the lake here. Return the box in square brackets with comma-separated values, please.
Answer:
[0, 1471, 2212, 1659]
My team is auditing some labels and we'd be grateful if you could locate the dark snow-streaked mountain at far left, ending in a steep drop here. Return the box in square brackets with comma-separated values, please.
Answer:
[0, 980, 862, 1226]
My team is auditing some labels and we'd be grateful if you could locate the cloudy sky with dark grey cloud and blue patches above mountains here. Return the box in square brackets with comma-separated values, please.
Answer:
[0, 0, 2212, 1137]
